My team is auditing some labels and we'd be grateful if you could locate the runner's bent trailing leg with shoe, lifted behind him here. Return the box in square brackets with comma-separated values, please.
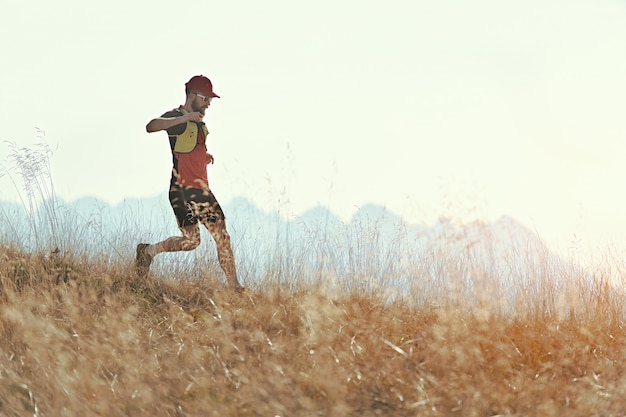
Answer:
[135, 224, 200, 276]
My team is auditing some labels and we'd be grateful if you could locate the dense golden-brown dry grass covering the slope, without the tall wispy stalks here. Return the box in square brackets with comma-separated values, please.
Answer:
[0, 240, 626, 417]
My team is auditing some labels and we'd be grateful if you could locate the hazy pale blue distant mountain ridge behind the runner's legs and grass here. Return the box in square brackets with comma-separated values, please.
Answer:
[0, 195, 568, 300]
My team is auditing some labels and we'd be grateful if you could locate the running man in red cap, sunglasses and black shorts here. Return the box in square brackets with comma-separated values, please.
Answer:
[135, 75, 243, 291]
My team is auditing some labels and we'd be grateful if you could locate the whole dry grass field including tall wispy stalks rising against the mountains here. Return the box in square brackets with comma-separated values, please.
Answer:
[0, 144, 626, 417]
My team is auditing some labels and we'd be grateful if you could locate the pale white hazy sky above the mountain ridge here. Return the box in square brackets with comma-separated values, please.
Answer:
[0, 0, 626, 255]
